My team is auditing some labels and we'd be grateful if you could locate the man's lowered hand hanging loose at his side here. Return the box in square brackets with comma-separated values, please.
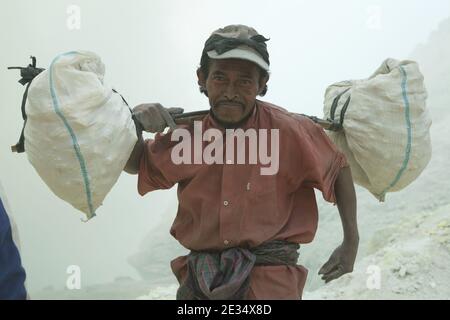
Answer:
[319, 241, 358, 283]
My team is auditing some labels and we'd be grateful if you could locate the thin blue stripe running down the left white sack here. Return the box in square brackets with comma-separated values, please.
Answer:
[49, 51, 95, 222]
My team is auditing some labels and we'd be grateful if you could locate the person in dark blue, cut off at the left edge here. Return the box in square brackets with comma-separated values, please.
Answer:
[0, 180, 27, 300]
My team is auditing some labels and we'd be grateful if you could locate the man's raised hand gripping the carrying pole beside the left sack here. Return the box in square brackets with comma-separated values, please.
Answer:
[133, 103, 184, 133]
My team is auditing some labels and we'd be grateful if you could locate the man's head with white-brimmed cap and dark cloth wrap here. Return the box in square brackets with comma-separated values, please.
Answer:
[197, 25, 269, 127]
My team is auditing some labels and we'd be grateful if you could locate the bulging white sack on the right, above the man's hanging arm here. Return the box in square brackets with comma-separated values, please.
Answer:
[324, 59, 431, 201]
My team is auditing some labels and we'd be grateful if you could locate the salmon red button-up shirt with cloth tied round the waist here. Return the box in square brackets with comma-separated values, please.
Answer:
[138, 100, 348, 299]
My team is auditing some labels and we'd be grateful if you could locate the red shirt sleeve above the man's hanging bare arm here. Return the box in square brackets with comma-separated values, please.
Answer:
[299, 117, 348, 203]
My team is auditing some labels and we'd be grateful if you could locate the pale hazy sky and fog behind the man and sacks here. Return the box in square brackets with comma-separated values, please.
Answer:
[0, 0, 450, 289]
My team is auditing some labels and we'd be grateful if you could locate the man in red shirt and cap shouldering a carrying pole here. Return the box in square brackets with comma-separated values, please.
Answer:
[125, 25, 359, 299]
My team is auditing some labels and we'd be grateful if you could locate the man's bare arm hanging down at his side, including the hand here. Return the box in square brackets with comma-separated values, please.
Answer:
[319, 167, 359, 282]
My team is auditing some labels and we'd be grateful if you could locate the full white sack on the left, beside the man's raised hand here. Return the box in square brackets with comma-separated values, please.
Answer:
[25, 51, 137, 218]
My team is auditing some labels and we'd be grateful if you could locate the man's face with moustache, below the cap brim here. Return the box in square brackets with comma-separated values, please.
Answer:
[198, 59, 267, 125]
